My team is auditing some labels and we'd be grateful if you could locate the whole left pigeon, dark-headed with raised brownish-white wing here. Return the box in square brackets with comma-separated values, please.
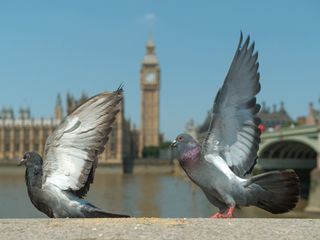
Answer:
[19, 87, 129, 218]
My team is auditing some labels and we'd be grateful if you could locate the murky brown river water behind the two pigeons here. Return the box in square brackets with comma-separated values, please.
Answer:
[0, 167, 320, 218]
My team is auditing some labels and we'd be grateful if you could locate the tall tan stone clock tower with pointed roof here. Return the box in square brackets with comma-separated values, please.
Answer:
[139, 38, 160, 157]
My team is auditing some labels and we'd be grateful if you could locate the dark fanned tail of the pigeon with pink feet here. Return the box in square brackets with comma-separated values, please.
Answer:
[246, 170, 300, 214]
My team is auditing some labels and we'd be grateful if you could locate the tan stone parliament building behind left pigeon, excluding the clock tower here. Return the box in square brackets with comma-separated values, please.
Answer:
[0, 94, 137, 164]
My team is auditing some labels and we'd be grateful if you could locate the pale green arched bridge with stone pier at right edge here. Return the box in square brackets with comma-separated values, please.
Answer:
[257, 125, 320, 211]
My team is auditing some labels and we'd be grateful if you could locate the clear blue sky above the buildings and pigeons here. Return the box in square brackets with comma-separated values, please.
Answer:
[0, 0, 320, 139]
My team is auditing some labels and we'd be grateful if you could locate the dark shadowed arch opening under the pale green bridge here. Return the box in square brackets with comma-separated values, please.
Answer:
[258, 137, 317, 199]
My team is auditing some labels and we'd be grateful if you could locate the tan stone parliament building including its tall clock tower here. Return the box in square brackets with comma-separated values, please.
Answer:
[0, 39, 160, 164]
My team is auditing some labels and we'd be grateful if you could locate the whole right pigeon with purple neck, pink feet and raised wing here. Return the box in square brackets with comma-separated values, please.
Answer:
[171, 32, 299, 218]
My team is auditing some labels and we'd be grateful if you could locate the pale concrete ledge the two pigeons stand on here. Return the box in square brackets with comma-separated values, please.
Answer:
[0, 218, 320, 240]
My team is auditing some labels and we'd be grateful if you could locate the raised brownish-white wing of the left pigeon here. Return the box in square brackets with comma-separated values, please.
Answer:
[42, 87, 122, 197]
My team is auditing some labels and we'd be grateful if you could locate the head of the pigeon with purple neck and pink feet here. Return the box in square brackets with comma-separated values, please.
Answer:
[171, 133, 201, 162]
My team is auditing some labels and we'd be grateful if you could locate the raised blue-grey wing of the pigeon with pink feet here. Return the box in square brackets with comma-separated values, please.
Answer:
[202, 33, 260, 177]
